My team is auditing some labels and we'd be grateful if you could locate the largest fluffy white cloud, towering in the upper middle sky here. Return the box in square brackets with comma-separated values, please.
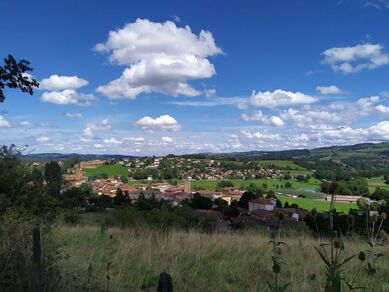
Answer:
[95, 19, 222, 99]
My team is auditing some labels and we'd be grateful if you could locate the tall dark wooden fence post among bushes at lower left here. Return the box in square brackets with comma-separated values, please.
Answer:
[32, 226, 43, 292]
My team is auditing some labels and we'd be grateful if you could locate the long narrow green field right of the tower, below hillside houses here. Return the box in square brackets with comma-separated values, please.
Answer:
[192, 179, 320, 190]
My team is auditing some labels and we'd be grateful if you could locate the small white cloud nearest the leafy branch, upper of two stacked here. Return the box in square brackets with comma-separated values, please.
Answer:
[39, 75, 88, 91]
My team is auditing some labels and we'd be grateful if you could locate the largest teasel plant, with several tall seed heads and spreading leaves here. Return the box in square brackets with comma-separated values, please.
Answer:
[311, 182, 363, 292]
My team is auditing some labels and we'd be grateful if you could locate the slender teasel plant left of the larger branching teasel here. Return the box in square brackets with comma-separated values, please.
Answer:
[267, 213, 290, 292]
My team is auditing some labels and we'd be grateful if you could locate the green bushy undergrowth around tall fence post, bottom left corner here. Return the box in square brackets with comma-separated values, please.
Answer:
[0, 211, 61, 291]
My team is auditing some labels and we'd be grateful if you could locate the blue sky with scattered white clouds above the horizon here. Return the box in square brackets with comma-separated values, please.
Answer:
[0, 0, 389, 155]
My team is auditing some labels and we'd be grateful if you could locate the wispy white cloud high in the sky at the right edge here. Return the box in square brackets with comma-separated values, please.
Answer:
[323, 43, 389, 74]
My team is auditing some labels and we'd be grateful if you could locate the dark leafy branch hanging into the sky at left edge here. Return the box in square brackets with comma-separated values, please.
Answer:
[0, 55, 39, 102]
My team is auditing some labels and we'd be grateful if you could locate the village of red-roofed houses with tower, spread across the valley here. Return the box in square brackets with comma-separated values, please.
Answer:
[57, 157, 320, 227]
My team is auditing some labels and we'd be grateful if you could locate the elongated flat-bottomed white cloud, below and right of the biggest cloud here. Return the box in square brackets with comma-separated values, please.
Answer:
[249, 89, 318, 108]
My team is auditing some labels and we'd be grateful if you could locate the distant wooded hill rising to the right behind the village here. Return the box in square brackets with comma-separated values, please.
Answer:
[185, 142, 389, 179]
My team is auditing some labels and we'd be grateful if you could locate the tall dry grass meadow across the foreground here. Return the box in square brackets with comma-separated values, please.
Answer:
[55, 226, 389, 292]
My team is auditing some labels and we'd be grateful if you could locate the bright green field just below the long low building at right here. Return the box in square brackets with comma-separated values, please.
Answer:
[277, 196, 358, 214]
